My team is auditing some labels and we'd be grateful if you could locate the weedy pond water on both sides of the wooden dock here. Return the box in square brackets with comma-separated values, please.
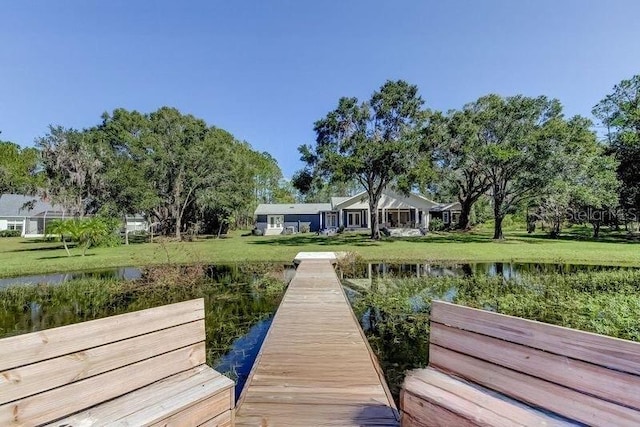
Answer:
[0, 263, 640, 404]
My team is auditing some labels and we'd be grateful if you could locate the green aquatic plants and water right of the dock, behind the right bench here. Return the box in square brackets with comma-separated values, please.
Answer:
[350, 269, 640, 397]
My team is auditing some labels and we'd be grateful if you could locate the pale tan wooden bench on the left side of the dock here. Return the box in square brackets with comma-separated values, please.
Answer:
[0, 299, 234, 427]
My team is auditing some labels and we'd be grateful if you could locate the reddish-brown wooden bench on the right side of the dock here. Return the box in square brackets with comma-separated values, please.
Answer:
[400, 301, 640, 426]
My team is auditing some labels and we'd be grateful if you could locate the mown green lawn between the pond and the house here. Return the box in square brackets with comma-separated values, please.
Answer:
[0, 229, 640, 277]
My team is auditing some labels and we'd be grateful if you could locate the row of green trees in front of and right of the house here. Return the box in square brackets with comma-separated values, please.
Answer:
[293, 76, 640, 239]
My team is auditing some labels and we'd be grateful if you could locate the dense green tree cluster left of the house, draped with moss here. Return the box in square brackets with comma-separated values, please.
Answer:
[0, 107, 293, 238]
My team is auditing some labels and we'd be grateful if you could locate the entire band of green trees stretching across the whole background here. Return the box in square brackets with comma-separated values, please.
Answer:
[0, 76, 640, 239]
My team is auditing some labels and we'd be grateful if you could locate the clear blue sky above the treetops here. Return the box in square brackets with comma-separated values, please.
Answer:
[0, 0, 640, 177]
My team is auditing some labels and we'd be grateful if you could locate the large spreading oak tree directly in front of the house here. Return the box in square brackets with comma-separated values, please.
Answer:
[299, 80, 426, 239]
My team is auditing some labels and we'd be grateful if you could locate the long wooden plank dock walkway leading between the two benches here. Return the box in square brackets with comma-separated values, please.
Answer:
[236, 259, 399, 427]
